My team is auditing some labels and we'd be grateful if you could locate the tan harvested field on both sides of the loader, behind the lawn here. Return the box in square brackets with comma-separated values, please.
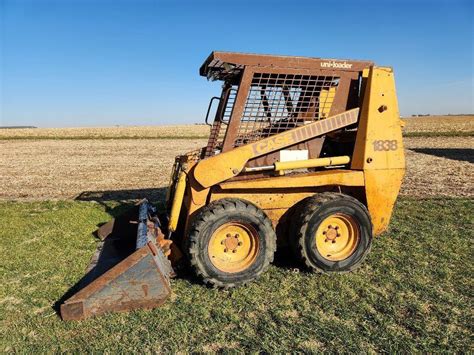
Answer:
[0, 137, 474, 200]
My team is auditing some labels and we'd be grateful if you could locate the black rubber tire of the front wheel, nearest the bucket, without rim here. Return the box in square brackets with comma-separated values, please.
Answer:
[187, 198, 276, 288]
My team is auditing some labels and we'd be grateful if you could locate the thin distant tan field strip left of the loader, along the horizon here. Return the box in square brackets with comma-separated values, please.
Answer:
[0, 124, 209, 139]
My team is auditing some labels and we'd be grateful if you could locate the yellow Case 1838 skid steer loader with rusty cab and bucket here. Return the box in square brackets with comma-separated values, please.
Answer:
[61, 52, 405, 319]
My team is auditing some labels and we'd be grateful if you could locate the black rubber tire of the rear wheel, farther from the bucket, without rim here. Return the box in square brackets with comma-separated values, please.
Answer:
[290, 192, 372, 273]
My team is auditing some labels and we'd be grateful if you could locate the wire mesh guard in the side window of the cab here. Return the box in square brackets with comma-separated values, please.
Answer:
[234, 73, 339, 146]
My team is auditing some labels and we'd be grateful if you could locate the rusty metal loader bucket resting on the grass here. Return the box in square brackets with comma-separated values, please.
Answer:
[61, 200, 173, 320]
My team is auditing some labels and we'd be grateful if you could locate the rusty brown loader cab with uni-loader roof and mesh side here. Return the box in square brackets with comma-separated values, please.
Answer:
[201, 52, 366, 158]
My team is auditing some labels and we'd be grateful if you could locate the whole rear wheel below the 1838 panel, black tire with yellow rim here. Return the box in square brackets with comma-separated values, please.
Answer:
[291, 192, 372, 272]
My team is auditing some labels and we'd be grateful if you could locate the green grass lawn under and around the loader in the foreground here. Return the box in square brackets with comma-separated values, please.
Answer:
[0, 199, 474, 353]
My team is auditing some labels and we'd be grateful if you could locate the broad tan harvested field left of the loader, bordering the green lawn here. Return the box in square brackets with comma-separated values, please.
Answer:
[0, 139, 205, 199]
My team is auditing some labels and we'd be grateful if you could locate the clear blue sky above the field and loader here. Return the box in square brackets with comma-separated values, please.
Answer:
[0, 0, 474, 127]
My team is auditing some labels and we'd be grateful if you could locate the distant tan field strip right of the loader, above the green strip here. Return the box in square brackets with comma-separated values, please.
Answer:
[403, 115, 474, 133]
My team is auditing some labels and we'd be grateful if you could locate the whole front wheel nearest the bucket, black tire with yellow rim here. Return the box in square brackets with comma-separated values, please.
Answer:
[188, 199, 276, 288]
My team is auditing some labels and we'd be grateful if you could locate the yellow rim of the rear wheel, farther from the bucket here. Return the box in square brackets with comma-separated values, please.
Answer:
[316, 213, 360, 261]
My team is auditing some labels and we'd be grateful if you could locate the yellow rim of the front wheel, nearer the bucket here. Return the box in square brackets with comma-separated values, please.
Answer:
[208, 223, 259, 273]
